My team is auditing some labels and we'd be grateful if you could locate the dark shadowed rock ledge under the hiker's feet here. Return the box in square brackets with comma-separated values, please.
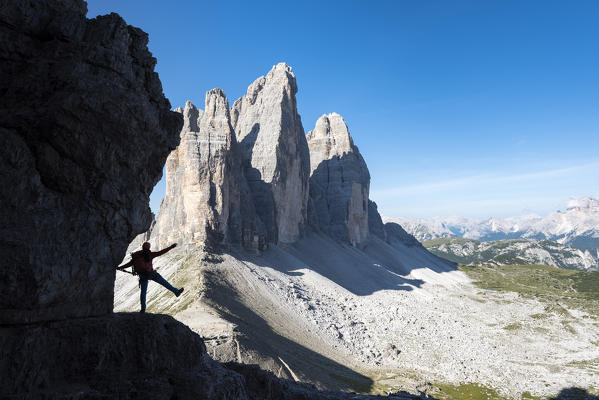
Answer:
[0, 314, 247, 399]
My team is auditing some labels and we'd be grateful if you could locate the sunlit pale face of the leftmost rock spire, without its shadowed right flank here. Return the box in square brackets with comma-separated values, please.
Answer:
[151, 89, 234, 247]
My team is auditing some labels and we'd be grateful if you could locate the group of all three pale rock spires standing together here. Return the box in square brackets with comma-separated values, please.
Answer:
[146, 63, 386, 250]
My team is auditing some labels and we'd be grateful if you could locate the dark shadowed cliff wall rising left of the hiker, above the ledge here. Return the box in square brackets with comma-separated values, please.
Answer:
[0, 0, 182, 324]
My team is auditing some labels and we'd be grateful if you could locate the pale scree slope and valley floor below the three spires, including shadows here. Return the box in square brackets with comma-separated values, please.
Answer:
[115, 234, 599, 399]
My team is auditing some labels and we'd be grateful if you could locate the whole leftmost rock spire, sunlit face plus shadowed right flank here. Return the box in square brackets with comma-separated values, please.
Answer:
[149, 89, 264, 250]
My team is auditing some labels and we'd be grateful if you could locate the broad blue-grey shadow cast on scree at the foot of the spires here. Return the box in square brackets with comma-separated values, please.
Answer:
[233, 233, 455, 296]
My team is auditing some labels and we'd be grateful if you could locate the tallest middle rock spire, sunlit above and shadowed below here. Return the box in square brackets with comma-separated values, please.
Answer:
[231, 63, 310, 243]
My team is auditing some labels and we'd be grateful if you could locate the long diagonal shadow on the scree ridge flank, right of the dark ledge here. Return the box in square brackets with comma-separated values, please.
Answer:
[205, 271, 374, 393]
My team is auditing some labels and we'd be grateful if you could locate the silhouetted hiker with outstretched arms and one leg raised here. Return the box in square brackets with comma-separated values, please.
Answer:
[118, 242, 184, 313]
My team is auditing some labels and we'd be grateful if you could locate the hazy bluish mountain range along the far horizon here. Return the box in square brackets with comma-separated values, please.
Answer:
[383, 197, 599, 256]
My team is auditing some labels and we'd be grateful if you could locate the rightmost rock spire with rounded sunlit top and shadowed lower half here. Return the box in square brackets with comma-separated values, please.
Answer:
[307, 113, 370, 246]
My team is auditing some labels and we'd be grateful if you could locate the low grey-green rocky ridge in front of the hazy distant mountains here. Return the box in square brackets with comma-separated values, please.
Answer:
[423, 237, 599, 271]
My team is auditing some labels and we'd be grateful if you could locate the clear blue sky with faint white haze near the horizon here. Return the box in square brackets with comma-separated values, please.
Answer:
[88, 0, 599, 218]
